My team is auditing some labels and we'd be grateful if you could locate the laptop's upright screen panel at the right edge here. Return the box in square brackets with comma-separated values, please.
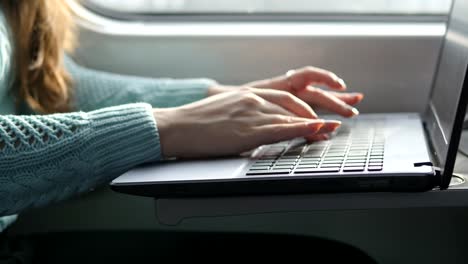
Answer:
[426, 0, 468, 187]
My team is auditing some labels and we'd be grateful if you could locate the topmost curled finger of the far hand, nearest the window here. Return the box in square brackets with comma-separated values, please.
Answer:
[285, 67, 346, 91]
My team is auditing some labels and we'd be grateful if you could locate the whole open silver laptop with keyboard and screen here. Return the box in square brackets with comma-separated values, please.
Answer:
[110, 1, 468, 198]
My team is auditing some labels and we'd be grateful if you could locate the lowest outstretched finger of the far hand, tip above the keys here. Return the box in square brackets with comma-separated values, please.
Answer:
[297, 86, 359, 117]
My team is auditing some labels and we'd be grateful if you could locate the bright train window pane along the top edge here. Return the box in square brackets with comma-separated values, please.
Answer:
[84, 0, 451, 17]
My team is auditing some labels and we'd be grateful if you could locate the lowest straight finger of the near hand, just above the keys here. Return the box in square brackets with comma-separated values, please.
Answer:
[256, 119, 323, 144]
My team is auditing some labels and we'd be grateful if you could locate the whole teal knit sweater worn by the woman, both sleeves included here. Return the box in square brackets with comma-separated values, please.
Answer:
[0, 9, 215, 231]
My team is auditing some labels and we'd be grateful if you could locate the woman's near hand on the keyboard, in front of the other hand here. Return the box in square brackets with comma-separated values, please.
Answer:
[154, 88, 340, 158]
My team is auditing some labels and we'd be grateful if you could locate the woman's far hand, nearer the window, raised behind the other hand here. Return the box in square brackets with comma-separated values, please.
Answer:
[209, 67, 364, 117]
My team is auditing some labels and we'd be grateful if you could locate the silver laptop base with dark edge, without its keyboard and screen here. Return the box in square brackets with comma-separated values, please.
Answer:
[111, 113, 440, 198]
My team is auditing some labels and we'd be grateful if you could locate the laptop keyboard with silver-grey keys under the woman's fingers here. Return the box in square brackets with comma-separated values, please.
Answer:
[247, 124, 385, 175]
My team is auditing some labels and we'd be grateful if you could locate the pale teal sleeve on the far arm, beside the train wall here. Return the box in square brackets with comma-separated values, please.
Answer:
[65, 56, 216, 111]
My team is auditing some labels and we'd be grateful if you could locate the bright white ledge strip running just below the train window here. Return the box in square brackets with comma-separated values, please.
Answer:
[68, 0, 446, 37]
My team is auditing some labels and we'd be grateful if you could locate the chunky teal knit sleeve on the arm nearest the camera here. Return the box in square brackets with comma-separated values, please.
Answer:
[0, 103, 160, 216]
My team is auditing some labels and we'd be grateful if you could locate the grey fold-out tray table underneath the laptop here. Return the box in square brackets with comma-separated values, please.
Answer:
[155, 154, 468, 225]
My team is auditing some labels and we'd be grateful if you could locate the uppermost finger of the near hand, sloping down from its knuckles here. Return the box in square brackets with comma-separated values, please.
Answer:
[252, 88, 317, 118]
